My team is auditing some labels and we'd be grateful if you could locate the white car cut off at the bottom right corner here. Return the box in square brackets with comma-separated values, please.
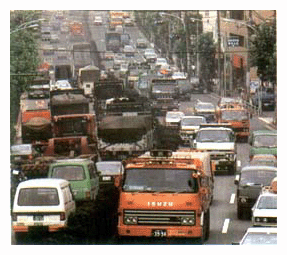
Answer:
[233, 227, 277, 245]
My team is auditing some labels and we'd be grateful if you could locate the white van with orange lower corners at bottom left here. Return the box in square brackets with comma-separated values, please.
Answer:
[12, 178, 76, 235]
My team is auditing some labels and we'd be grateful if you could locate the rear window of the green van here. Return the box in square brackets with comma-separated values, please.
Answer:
[51, 166, 85, 181]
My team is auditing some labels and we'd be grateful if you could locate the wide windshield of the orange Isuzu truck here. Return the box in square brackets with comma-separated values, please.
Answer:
[123, 169, 198, 193]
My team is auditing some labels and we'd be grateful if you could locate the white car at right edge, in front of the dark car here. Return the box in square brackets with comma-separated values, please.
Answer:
[252, 188, 277, 227]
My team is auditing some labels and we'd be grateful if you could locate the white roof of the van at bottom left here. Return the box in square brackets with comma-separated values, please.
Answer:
[18, 178, 69, 188]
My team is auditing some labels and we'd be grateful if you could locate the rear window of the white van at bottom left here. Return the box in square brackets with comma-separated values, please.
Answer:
[18, 188, 59, 206]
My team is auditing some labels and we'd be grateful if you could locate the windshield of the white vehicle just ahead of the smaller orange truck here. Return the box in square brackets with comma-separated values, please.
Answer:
[196, 129, 232, 142]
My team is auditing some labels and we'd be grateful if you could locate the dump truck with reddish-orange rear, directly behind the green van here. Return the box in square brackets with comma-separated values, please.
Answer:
[44, 89, 97, 156]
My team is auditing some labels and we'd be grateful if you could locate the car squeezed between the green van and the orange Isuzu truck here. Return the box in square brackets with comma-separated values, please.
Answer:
[96, 161, 124, 188]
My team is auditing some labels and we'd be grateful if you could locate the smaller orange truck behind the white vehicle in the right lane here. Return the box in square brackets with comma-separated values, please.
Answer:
[216, 104, 250, 141]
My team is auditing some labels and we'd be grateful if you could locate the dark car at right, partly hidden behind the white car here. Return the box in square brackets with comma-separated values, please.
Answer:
[234, 166, 277, 219]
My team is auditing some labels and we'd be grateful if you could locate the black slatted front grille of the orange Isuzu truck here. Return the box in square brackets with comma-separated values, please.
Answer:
[124, 210, 195, 226]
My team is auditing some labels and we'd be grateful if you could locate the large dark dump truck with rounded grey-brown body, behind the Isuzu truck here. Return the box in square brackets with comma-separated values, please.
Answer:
[98, 97, 153, 160]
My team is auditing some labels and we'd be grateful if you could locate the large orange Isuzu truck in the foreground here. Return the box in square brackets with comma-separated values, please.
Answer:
[115, 149, 214, 242]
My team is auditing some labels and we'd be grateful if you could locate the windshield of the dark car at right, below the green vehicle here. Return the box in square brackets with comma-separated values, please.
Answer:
[240, 169, 277, 186]
